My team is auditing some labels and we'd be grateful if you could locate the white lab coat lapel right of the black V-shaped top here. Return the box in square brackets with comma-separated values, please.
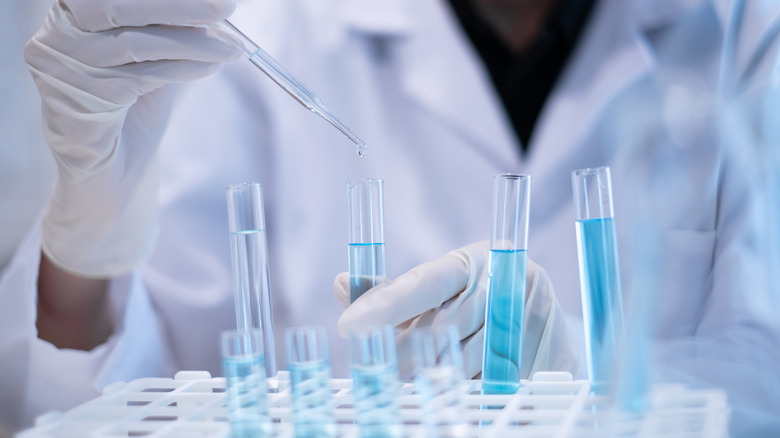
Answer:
[529, 0, 654, 174]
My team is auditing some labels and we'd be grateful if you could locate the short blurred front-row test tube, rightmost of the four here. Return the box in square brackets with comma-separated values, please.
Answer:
[412, 325, 468, 437]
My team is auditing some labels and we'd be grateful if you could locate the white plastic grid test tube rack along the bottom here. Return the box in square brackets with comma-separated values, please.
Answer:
[18, 371, 729, 438]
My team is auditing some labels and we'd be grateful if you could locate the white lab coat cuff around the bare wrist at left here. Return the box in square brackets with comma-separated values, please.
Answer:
[0, 220, 172, 431]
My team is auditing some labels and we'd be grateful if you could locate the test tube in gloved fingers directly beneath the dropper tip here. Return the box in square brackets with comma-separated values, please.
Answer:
[347, 178, 387, 302]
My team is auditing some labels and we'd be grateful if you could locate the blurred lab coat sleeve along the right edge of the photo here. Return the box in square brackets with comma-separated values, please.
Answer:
[661, 7, 780, 436]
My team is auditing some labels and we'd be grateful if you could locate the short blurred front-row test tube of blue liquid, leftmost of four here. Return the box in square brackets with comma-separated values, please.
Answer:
[221, 329, 271, 438]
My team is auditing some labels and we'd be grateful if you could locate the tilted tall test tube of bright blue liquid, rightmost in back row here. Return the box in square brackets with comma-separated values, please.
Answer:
[572, 167, 624, 393]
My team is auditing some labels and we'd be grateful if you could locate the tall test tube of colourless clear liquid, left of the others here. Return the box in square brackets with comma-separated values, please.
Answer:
[227, 183, 276, 377]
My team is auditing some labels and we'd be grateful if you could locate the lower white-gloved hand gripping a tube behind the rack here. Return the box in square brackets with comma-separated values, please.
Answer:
[334, 241, 577, 378]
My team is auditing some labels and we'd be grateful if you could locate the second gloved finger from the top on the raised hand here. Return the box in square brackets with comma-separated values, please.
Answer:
[33, 10, 240, 68]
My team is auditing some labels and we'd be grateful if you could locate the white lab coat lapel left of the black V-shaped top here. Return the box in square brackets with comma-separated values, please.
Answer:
[342, 0, 518, 170]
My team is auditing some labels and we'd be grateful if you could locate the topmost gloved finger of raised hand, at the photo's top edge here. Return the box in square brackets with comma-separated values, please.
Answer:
[61, 0, 236, 32]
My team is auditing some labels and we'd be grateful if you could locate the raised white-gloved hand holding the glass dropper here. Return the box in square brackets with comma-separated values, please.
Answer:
[24, 0, 239, 276]
